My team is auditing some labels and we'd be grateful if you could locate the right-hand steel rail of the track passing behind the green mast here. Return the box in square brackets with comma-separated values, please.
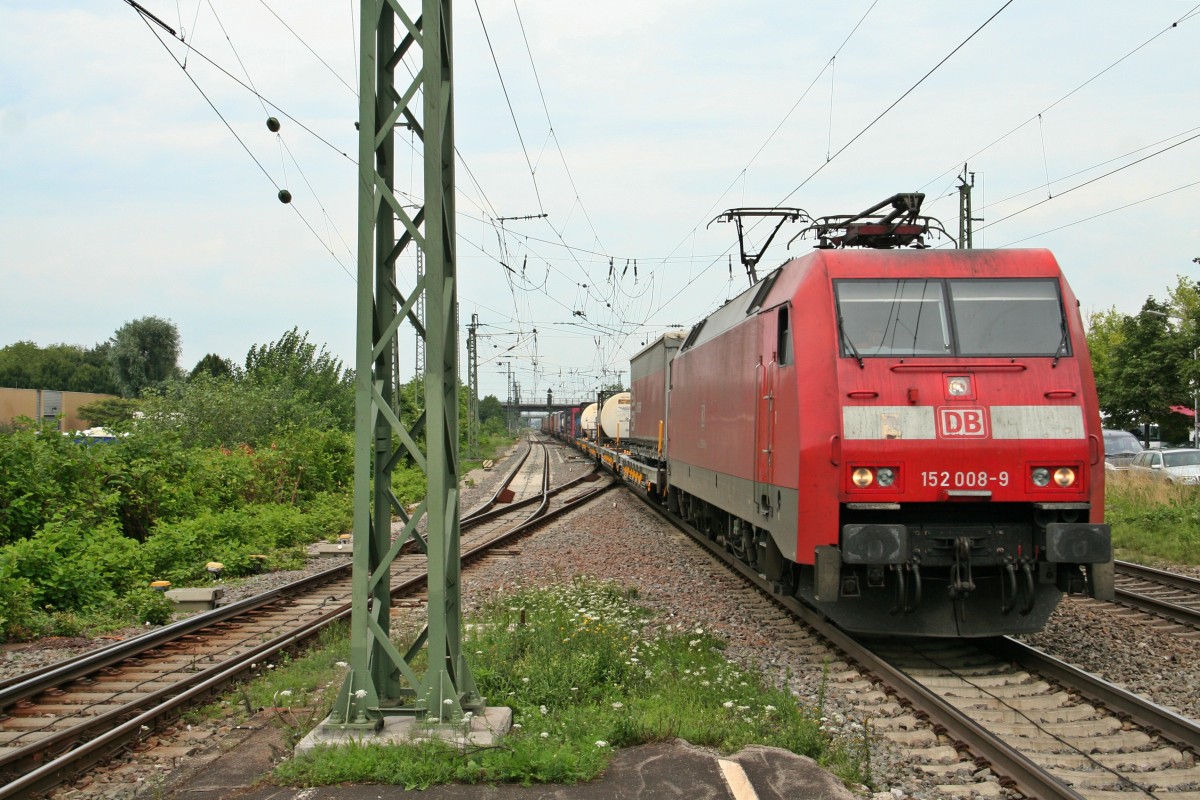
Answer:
[0, 460, 617, 800]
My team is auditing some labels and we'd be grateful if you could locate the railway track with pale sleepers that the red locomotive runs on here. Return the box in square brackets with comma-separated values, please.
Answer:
[633, 489, 1200, 800]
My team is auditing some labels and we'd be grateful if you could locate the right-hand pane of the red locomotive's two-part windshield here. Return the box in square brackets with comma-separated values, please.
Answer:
[949, 279, 1070, 356]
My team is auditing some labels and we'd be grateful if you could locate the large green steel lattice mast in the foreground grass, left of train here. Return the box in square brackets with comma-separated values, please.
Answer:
[325, 0, 484, 729]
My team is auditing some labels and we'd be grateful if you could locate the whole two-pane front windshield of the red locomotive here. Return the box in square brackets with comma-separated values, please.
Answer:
[834, 278, 1070, 357]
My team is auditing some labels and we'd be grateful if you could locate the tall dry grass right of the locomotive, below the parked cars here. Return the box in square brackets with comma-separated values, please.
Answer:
[1104, 473, 1200, 565]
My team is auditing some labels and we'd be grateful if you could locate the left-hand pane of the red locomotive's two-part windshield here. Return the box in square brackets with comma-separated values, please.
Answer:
[834, 279, 950, 357]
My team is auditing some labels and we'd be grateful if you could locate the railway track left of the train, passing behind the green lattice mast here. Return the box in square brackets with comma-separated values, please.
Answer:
[0, 443, 613, 799]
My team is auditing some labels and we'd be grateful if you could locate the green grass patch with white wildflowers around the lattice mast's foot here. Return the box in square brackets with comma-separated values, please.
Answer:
[277, 581, 870, 788]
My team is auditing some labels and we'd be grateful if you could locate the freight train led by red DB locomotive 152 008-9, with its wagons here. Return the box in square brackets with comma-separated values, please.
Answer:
[547, 196, 1112, 637]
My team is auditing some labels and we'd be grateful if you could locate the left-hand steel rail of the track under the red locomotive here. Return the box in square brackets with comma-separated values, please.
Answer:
[636, 493, 1085, 800]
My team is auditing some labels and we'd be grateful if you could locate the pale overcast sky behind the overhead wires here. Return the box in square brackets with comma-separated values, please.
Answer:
[0, 0, 1200, 399]
